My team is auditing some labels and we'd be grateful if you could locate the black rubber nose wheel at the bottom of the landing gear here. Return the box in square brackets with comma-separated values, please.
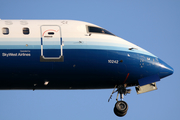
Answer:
[114, 101, 128, 117]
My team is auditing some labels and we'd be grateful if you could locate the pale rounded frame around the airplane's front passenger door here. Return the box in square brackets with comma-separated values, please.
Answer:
[40, 25, 64, 62]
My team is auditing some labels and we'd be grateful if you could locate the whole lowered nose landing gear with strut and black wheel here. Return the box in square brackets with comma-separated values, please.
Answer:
[108, 85, 131, 117]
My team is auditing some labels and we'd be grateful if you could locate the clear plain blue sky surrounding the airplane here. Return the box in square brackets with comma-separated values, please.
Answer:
[0, 0, 180, 120]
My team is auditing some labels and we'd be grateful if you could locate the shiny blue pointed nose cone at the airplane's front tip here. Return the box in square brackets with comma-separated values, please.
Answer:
[159, 59, 174, 78]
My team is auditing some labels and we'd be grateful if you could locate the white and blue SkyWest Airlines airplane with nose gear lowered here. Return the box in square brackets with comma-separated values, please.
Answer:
[0, 20, 174, 117]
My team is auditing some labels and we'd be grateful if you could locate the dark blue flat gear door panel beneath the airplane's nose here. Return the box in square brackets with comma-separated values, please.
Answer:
[138, 75, 160, 86]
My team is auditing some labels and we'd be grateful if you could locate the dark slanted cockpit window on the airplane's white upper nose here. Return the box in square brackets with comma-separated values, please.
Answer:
[88, 26, 114, 35]
